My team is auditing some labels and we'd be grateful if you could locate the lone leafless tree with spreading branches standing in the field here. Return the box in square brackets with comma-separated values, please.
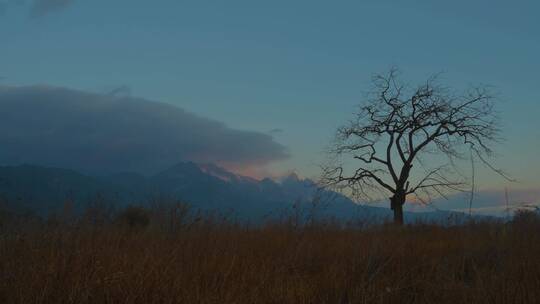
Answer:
[322, 69, 505, 224]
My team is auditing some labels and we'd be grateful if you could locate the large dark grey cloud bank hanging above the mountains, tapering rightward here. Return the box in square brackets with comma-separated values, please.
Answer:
[0, 86, 288, 174]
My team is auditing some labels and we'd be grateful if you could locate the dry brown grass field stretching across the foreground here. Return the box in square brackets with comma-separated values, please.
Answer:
[0, 217, 540, 304]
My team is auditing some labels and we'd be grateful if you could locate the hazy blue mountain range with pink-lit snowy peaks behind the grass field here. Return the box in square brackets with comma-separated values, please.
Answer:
[0, 162, 480, 221]
